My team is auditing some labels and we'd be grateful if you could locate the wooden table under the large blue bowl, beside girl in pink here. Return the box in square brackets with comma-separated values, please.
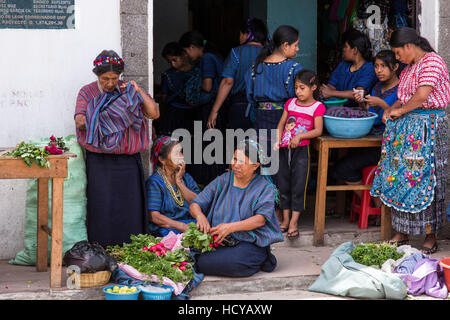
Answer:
[312, 135, 391, 246]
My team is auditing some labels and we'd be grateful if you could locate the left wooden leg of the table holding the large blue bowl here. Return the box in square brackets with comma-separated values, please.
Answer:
[313, 142, 329, 246]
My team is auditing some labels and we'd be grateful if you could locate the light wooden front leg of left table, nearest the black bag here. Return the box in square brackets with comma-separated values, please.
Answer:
[50, 178, 64, 288]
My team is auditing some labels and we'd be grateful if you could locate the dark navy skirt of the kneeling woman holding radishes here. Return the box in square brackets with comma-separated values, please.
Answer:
[195, 241, 277, 277]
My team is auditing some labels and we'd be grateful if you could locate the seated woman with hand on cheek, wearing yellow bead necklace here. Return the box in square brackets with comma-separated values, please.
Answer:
[146, 136, 200, 236]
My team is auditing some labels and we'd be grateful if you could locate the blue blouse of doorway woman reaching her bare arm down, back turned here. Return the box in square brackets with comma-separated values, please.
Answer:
[222, 44, 262, 96]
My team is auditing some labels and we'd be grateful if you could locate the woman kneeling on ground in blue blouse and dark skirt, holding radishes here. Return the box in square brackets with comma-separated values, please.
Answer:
[190, 139, 283, 277]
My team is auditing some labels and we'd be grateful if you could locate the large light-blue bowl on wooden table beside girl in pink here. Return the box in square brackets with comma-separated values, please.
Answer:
[323, 112, 378, 138]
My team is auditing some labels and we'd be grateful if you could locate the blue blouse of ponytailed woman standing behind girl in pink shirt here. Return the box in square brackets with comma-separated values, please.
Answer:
[245, 59, 303, 105]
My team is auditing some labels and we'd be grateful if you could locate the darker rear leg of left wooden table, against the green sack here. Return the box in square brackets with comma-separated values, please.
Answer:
[36, 178, 48, 272]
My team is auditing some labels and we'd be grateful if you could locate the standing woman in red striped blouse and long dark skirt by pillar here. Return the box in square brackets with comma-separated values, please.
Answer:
[75, 50, 159, 246]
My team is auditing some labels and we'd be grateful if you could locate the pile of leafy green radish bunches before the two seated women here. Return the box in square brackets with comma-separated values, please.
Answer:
[106, 234, 194, 283]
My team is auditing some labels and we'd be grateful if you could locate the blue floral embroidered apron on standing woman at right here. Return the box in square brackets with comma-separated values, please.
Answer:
[370, 110, 445, 213]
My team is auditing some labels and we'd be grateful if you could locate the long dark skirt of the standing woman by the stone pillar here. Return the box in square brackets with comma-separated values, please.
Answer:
[86, 151, 149, 246]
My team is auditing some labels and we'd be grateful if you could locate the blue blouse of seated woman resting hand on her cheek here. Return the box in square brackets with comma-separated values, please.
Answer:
[146, 172, 200, 232]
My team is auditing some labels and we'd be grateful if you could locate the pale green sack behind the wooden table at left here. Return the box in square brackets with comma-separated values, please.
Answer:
[9, 135, 87, 266]
